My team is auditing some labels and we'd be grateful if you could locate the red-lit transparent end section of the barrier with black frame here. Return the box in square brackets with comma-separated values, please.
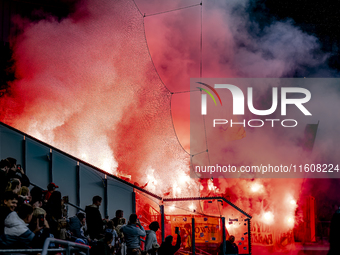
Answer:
[136, 191, 252, 255]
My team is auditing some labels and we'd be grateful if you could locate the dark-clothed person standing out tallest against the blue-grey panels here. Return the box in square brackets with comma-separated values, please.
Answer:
[85, 196, 104, 239]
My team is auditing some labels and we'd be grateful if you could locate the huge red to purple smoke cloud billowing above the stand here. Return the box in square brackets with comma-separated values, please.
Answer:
[0, 0, 338, 245]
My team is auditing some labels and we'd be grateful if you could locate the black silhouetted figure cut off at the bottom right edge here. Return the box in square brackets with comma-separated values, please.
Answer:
[328, 208, 340, 255]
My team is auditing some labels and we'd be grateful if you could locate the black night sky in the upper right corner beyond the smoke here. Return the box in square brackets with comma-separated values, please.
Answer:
[249, 0, 340, 70]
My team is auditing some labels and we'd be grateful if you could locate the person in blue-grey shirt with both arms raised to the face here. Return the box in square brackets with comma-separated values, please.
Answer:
[120, 213, 146, 255]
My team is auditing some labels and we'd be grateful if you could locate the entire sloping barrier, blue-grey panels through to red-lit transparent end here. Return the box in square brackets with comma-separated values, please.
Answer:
[0, 123, 251, 255]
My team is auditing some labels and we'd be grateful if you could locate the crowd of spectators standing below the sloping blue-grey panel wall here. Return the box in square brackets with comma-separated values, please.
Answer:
[0, 158, 168, 255]
